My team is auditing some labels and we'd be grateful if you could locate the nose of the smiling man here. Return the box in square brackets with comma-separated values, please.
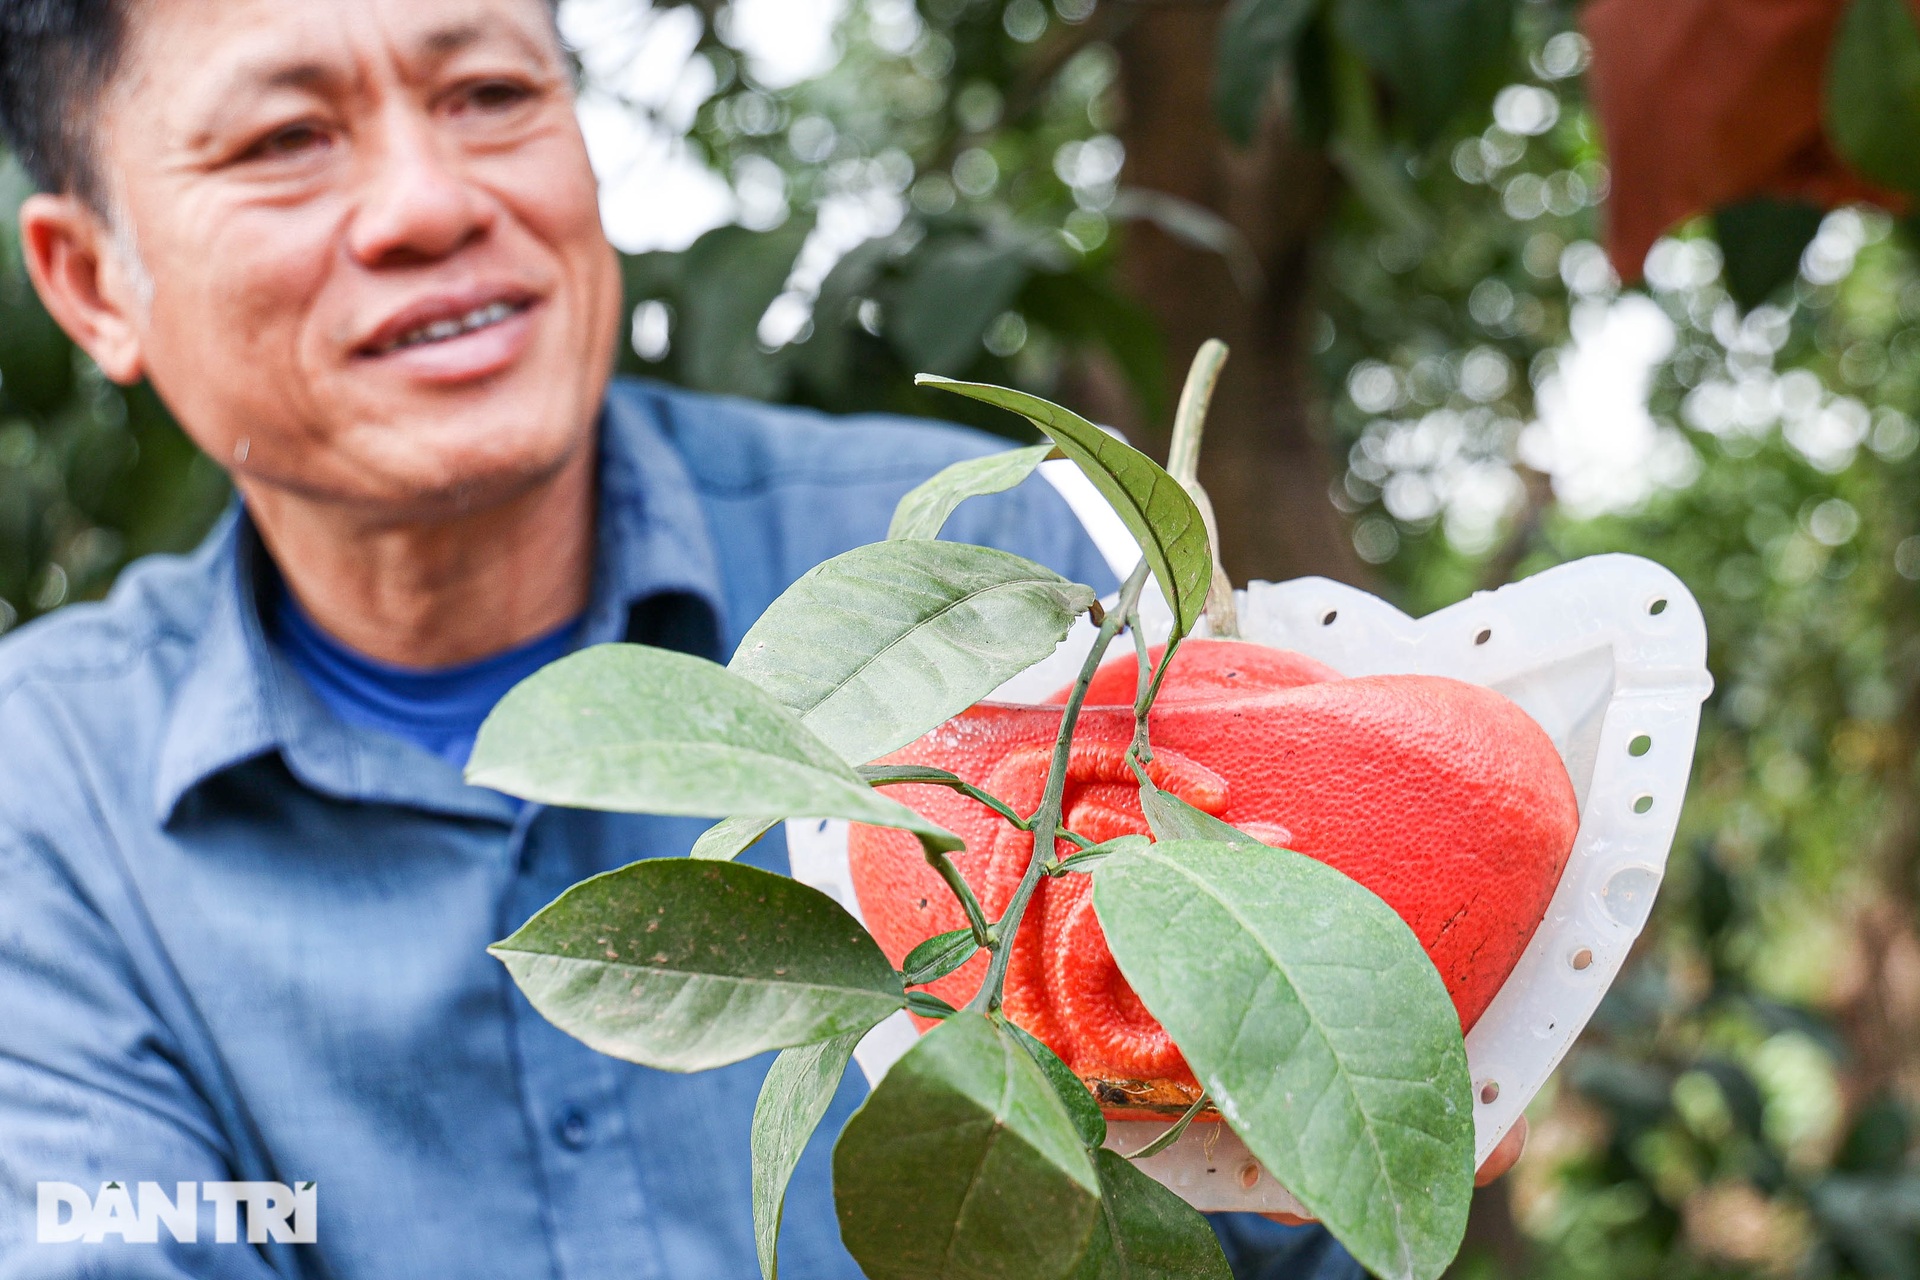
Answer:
[348, 107, 493, 267]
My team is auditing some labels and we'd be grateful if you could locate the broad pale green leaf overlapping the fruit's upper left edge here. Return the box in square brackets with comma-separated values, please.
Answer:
[730, 539, 1094, 759]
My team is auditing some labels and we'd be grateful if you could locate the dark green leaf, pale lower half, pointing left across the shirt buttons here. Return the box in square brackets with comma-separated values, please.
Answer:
[488, 858, 906, 1071]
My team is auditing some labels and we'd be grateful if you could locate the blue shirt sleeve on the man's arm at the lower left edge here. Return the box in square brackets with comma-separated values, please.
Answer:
[0, 829, 284, 1280]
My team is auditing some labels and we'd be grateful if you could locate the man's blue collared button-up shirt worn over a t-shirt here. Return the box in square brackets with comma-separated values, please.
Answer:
[0, 382, 1357, 1280]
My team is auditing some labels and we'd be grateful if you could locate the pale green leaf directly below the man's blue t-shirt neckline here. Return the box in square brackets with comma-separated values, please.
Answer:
[467, 645, 962, 848]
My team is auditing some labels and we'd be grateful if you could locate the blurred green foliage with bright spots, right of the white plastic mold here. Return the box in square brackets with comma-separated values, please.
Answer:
[1321, 10, 1920, 1280]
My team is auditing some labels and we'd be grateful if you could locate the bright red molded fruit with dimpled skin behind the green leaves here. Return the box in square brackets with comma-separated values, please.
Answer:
[849, 641, 1578, 1105]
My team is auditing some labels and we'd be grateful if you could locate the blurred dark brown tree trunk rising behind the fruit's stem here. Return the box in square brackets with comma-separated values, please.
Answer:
[1117, 4, 1367, 583]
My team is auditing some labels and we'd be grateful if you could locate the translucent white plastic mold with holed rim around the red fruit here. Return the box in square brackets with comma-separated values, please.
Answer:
[787, 464, 1713, 1213]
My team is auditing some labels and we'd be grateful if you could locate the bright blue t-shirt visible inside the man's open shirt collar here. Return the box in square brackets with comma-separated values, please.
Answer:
[269, 583, 580, 770]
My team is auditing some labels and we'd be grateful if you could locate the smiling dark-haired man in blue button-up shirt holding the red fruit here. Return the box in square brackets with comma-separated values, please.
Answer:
[0, 0, 1512, 1280]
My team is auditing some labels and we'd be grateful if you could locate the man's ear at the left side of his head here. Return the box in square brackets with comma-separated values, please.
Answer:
[19, 194, 146, 384]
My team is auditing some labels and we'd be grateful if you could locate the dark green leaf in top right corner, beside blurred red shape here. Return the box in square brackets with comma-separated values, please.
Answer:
[1826, 0, 1920, 196]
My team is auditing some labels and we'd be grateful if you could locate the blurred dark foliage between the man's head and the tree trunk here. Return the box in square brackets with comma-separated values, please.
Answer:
[588, 0, 1169, 432]
